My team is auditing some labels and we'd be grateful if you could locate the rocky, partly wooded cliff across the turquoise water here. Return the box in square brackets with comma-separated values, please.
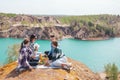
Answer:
[0, 14, 120, 40]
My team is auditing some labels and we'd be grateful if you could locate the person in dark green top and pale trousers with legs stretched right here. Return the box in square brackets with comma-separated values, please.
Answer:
[45, 41, 71, 70]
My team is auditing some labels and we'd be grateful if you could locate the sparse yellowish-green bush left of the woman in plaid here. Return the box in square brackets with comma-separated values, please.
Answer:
[6, 44, 20, 63]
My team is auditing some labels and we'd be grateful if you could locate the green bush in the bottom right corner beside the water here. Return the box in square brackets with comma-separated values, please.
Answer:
[105, 64, 119, 80]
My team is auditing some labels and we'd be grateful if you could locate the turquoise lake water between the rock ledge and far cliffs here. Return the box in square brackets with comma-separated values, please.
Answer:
[0, 38, 120, 72]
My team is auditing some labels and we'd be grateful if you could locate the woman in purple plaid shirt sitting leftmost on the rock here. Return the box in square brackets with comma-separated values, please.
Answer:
[18, 39, 32, 69]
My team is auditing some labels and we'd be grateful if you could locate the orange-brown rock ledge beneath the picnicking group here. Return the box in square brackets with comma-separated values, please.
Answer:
[0, 59, 101, 80]
